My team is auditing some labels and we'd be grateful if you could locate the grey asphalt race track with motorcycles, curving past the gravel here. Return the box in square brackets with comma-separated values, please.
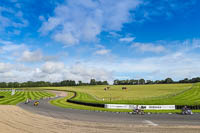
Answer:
[18, 97, 200, 126]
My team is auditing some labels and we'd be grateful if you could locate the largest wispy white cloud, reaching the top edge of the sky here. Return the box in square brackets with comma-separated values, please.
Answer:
[39, 0, 141, 46]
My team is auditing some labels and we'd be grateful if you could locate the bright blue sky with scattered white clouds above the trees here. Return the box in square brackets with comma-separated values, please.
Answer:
[0, 0, 200, 83]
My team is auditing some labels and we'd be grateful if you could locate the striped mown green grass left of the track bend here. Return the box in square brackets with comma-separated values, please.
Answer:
[0, 91, 55, 105]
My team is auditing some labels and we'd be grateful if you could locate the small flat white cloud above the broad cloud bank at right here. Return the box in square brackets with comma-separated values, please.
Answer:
[131, 42, 165, 53]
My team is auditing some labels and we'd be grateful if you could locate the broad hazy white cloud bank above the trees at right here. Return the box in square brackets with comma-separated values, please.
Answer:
[86, 52, 200, 80]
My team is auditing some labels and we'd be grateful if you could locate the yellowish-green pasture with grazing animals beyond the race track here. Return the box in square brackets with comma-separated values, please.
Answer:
[38, 84, 192, 101]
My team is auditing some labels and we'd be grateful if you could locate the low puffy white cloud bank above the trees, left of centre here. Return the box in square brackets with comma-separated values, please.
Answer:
[30, 62, 113, 82]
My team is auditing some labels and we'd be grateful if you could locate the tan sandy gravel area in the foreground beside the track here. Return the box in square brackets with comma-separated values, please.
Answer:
[0, 105, 200, 133]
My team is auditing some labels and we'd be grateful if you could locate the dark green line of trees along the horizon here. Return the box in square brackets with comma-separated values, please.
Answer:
[0, 77, 200, 88]
